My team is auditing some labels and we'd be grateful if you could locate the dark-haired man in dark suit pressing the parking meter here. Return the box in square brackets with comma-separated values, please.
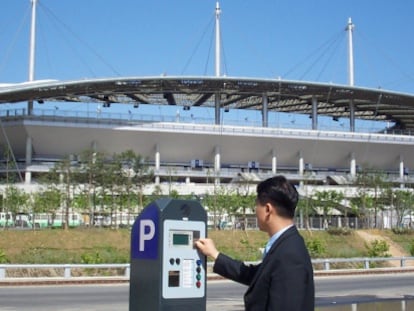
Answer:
[195, 176, 315, 311]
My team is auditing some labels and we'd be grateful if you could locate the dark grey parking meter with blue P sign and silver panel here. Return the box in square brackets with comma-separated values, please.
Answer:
[129, 199, 207, 311]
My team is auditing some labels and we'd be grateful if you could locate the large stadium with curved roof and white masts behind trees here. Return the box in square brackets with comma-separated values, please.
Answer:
[0, 4, 414, 230]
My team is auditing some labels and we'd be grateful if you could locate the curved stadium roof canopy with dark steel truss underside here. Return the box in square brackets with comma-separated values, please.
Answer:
[0, 76, 414, 130]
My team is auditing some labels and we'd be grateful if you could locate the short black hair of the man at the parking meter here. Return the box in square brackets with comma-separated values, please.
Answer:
[256, 175, 299, 219]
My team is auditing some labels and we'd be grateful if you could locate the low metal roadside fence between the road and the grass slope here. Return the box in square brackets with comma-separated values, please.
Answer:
[0, 257, 414, 282]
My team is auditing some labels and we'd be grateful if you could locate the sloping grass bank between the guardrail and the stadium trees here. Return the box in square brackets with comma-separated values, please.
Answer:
[0, 229, 394, 264]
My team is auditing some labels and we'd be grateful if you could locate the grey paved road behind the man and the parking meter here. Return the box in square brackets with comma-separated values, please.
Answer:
[0, 273, 414, 311]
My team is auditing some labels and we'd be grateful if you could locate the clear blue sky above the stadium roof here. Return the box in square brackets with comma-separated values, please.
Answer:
[0, 0, 414, 129]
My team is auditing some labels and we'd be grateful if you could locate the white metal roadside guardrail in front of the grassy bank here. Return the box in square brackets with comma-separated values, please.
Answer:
[0, 257, 414, 282]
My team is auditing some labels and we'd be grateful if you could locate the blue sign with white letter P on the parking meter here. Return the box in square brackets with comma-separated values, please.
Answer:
[131, 205, 158, 259]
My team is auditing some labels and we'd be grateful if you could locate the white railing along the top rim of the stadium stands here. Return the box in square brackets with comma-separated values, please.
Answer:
[0, 108, 414, 143]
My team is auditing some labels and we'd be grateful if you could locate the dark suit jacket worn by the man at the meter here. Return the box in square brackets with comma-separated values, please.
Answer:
[213, 226, 315, 311]
